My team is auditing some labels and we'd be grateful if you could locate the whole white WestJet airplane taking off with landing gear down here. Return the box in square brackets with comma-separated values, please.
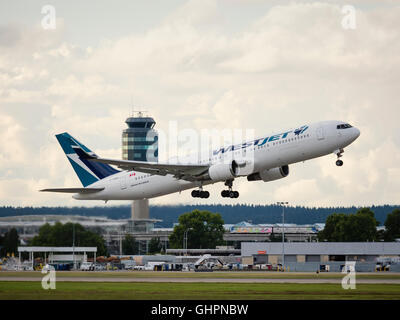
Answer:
[40, 121, 360, 202]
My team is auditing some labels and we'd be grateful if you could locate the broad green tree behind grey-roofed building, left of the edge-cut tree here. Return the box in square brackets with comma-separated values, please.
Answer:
[318, 208, 379, 242]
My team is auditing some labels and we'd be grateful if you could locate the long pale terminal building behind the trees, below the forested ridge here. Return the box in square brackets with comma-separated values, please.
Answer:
[0, 215, 323, 254]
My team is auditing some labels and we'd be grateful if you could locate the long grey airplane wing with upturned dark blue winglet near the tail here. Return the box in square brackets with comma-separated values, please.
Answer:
[73, 146, 209, 181]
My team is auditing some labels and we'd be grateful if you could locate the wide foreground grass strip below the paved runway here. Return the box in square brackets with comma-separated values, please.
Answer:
[0, 281, 400, 300]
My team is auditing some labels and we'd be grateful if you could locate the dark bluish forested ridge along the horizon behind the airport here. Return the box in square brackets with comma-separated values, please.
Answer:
[0, 205, 400, 227]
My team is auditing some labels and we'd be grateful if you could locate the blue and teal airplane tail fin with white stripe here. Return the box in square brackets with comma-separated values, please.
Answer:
[56, 132, 119, 187]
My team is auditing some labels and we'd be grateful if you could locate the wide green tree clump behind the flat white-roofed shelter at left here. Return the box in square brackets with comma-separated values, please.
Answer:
[31, 222, 107, 256]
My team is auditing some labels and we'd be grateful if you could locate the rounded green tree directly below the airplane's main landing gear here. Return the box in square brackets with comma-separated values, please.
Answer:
[169, 209, 224, 249]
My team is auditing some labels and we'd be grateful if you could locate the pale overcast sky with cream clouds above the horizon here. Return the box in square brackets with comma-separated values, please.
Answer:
[0, 0, 400, 206]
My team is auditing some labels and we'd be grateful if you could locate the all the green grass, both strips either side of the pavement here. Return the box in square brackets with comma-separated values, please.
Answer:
[0, 272, 400, 300]
